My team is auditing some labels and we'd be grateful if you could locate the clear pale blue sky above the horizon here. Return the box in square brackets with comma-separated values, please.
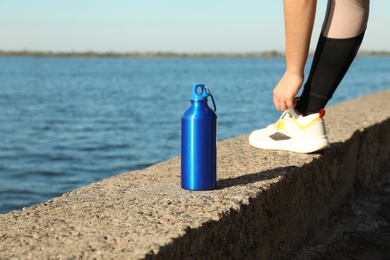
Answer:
[0, 0, 390, 52]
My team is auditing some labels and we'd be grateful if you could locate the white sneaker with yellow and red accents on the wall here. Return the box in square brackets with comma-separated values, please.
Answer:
[249, 108, 330, 153]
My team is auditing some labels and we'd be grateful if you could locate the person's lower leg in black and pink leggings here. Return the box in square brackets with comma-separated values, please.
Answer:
[295, 0, 369, 116]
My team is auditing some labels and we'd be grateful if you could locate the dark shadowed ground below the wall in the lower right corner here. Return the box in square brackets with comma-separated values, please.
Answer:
[293, 171, 390, 260]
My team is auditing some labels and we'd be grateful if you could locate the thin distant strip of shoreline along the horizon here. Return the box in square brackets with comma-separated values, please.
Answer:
[0, 50, 390, 58]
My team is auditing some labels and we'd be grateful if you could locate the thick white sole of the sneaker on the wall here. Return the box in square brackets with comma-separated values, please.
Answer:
[249, 135, 330, 153]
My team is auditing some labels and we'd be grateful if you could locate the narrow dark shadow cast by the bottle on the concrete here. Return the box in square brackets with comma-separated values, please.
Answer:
[216, 166, 297, 190]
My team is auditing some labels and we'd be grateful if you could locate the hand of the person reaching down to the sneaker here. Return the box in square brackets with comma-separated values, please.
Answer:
[273, 71, 304, 111]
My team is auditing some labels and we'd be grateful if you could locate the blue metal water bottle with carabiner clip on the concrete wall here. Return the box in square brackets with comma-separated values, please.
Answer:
[181, 84, 217, 190]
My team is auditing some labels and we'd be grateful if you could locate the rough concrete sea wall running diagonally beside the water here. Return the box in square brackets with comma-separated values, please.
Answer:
[0, 90, 390, 259]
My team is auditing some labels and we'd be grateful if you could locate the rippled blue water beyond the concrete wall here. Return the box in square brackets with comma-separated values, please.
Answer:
[0, 57, 390, 213]
